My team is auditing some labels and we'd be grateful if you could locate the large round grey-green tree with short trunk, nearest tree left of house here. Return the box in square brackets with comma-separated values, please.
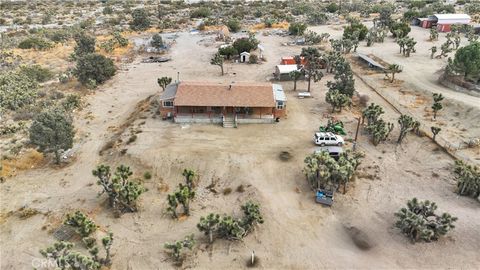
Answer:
[29, 109, 75, 164]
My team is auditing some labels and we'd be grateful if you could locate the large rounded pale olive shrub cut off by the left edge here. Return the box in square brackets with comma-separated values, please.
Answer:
[0, 71, 38, 111]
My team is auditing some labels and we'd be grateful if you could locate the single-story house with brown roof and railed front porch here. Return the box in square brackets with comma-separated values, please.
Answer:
[159, 82, 287, 126]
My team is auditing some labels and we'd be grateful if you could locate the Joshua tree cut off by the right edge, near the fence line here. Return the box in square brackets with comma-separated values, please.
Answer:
[454, 160, 480, 200]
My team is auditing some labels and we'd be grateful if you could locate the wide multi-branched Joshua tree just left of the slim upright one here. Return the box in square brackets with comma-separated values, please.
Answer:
[92, 165, 147, 212]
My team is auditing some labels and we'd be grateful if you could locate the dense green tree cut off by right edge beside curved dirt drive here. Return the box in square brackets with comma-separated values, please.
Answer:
[453, 41, 480, 83]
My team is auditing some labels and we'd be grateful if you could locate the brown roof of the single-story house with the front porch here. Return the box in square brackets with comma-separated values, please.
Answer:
[174, 82, 275, 107]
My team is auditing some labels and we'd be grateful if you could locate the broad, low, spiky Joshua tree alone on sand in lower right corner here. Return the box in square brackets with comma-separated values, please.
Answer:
[395, 198, 457, 242]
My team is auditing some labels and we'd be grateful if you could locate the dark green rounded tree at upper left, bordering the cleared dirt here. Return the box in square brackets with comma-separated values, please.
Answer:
[74, 53, 116, 87]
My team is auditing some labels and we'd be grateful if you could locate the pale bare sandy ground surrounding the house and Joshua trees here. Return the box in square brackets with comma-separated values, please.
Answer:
[0, 25, 480, 269]
